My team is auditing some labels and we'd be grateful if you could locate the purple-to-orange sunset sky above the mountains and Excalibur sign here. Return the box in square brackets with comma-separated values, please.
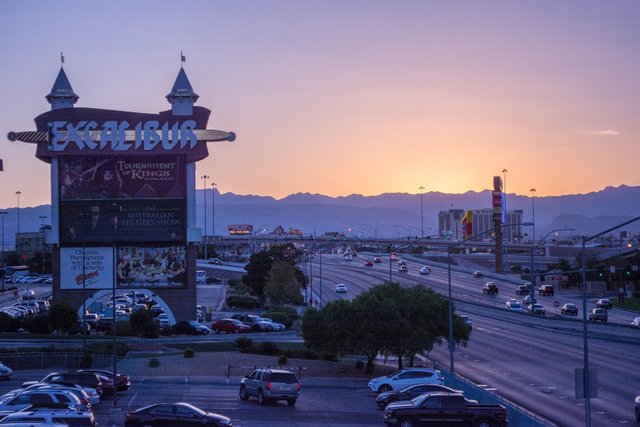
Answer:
[0, 0, 640, 208]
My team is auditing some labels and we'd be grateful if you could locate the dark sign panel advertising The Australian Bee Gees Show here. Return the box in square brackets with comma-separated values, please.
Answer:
[60, 199, 186, 245]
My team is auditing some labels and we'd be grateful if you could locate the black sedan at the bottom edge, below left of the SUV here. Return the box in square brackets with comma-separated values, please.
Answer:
[124, 402, 233, 427]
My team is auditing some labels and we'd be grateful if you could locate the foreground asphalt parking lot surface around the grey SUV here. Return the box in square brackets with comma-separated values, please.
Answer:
[0, 371, 383, 426]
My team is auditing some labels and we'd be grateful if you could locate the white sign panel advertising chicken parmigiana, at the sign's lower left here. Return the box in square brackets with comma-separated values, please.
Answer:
[60, 247, 113, 289]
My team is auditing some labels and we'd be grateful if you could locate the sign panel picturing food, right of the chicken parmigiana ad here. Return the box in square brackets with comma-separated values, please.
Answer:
[116, 246, 187, 288]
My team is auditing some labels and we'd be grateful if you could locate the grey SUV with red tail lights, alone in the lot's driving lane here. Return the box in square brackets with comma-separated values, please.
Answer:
[239, 369, 300, 406]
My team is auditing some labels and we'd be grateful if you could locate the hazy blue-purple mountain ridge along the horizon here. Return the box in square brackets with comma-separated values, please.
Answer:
[4, 185, 640, 246]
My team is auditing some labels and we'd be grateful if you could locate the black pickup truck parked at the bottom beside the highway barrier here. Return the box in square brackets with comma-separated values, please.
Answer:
[384, 392, 509, 427]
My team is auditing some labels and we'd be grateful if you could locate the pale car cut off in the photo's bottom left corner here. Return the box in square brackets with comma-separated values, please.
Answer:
[1, 404, 98, 427]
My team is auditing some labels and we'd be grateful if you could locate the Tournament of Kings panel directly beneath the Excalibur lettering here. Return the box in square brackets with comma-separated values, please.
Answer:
[58, 156, 186, 201]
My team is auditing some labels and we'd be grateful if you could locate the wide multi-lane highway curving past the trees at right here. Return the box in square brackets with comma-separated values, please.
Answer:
[306, 254, 640, 426]
